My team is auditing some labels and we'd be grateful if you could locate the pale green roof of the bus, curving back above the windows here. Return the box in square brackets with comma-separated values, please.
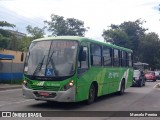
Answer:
[33, 36, 133, 52]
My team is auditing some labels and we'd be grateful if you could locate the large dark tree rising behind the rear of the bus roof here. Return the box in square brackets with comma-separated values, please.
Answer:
[102, 19, 147, 60]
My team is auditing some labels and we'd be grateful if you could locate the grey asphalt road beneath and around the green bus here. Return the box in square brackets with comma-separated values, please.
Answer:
[0, 81, 160, 120]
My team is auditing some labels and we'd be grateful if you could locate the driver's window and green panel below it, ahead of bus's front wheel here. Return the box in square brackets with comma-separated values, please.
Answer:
[76, 42, 90, 101]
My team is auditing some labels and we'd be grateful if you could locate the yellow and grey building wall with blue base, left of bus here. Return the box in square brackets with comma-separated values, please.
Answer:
[0, 50, 25, 83]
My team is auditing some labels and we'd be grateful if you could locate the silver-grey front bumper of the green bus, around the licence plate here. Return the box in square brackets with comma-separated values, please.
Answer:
[22, 85, 75, 102]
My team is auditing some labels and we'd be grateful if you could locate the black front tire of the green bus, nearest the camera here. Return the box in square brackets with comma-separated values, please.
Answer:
[86, 84, 96, 105]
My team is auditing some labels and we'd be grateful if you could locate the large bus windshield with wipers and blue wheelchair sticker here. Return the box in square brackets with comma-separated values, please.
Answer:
[24, 40, 78, 77]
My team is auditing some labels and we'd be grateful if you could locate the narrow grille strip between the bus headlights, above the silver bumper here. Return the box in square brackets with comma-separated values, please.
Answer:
[30, 85, 60, 91]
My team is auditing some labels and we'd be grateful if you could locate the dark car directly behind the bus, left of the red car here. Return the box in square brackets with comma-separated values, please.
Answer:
[132, 70, 146, 87]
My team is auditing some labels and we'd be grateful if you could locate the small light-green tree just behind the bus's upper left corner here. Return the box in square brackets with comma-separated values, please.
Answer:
[26, 25, 45, 39]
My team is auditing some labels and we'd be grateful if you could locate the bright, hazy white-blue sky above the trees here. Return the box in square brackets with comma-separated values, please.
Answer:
[0, 0, 160, 41]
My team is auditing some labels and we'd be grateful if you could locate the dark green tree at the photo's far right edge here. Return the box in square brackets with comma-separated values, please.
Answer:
[138, 32, 160, 69]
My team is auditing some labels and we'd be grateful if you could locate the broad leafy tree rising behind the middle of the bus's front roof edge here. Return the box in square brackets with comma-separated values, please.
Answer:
[44, 14, 89, 36]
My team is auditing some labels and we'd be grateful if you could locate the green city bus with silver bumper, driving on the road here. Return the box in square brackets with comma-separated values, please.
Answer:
[22, 36, 133, 104]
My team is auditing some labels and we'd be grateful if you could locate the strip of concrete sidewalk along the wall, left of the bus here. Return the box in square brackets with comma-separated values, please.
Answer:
[0, 84, 22, 91]
